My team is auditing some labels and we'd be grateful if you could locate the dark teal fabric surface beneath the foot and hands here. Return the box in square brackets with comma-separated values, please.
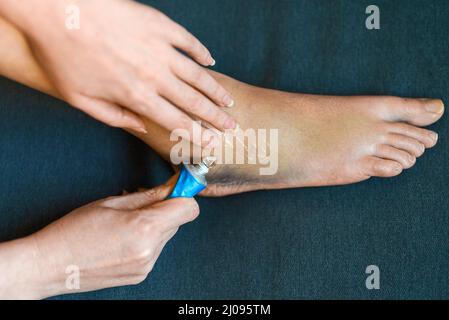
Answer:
[0, 0, 449, 299]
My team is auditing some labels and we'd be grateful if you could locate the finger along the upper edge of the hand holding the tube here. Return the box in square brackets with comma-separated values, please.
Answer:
[102, 184, 171, 210]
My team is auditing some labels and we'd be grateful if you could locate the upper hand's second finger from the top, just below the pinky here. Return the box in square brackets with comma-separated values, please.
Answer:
[172, 51, 234, 107]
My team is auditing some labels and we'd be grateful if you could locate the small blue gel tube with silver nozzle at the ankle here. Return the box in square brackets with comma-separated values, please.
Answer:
[167, 157, 215, 199]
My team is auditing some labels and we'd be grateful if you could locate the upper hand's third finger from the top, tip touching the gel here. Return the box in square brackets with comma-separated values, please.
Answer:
[161, 76, 236, 130]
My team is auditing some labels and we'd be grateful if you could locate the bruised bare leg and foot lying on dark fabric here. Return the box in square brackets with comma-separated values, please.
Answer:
[0, 18, 444, 196]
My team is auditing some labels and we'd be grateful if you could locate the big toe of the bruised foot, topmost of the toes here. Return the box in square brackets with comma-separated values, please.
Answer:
[378, 97, 444, 126]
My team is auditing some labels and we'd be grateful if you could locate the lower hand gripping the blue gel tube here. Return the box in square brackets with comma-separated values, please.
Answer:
[0, 185, 199, 298]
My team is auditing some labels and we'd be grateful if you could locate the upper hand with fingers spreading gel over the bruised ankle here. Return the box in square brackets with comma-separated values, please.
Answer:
[0, 0, 235, 146]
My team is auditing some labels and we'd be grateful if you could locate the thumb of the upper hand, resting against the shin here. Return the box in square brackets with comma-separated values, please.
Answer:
[71, 96, 147, 133]
